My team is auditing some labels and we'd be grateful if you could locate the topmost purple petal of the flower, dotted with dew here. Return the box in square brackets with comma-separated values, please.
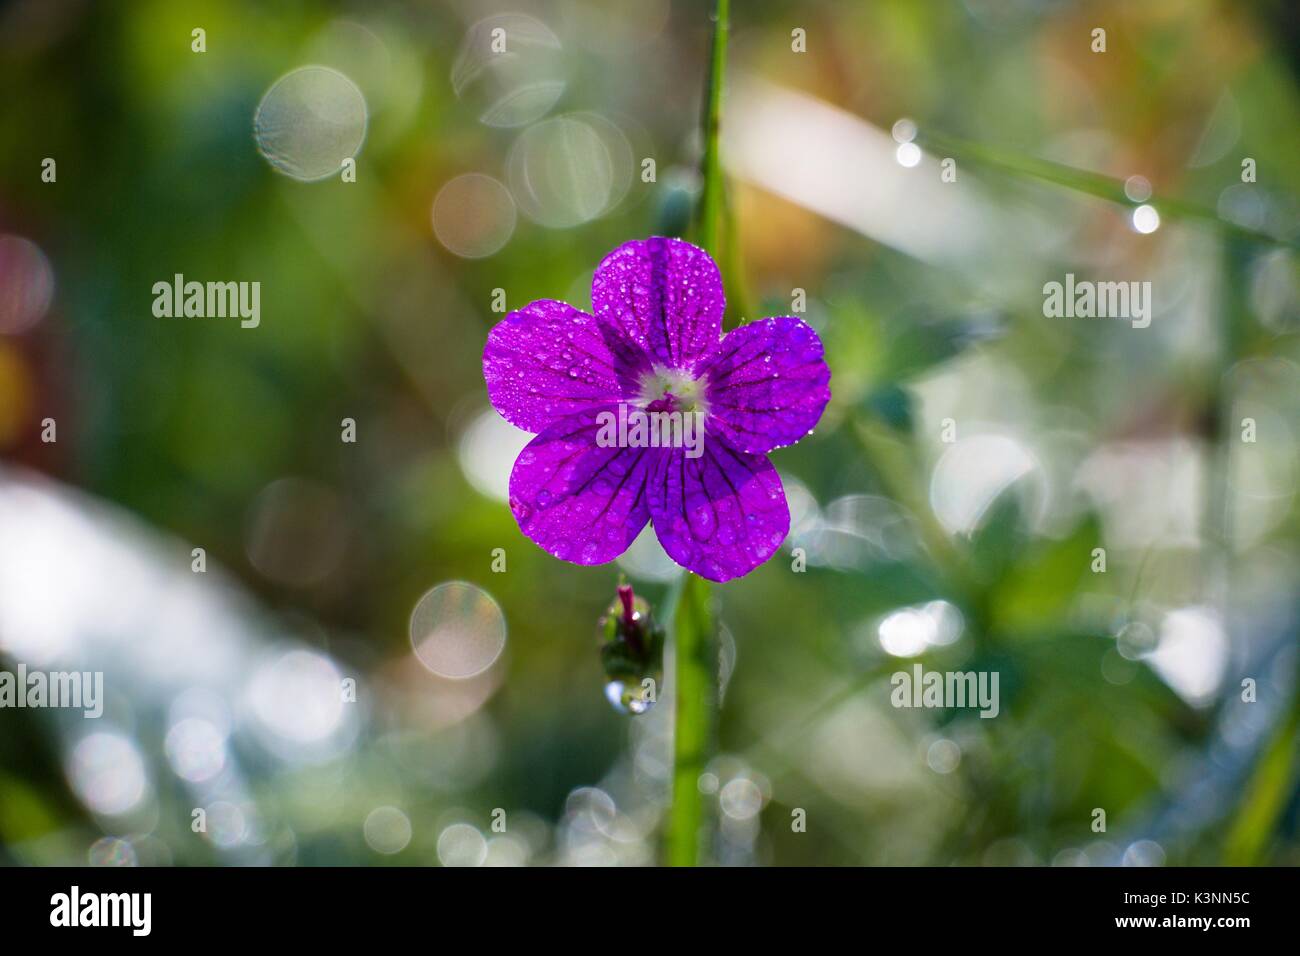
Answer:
[592, 238, 727, 372]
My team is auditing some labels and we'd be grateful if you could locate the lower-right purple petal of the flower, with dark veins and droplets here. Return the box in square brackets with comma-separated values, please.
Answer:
[649, 438, 790, 581]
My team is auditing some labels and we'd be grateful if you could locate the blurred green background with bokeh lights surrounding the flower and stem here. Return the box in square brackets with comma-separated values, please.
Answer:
[0, 0, 1300, 865]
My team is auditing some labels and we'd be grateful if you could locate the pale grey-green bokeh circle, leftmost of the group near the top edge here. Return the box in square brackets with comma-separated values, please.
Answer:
[254, 66, 368, 182]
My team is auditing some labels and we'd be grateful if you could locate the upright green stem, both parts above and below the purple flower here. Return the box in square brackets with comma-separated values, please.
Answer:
[667, 0, 729, 866]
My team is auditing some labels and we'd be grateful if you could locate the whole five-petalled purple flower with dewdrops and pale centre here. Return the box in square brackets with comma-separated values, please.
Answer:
[484, 238, 831, 581]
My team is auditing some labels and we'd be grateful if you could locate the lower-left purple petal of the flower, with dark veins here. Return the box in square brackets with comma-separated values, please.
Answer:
[510, 407, 650, 564]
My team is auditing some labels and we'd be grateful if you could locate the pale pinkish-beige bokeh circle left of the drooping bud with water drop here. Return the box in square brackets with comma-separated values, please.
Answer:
[411, 581, 506, 679]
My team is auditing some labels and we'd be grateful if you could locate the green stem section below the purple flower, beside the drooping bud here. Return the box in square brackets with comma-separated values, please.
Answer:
[668, 574, 718, 866]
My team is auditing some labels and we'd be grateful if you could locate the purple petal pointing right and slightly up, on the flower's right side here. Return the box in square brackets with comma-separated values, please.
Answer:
[701, 316, 831, 454]
